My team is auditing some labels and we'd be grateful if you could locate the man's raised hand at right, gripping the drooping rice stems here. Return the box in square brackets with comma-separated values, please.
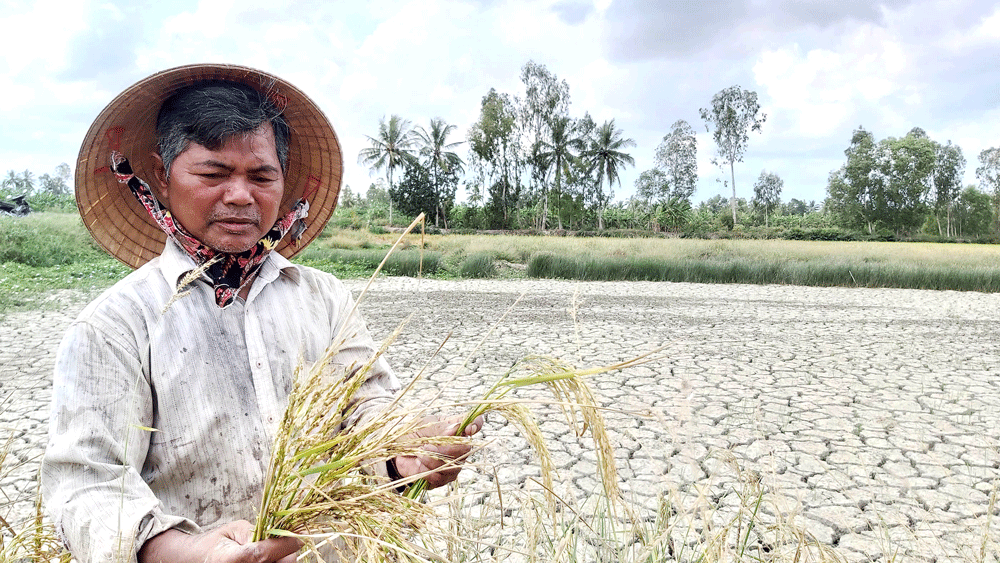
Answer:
[395, 416, 483, 489]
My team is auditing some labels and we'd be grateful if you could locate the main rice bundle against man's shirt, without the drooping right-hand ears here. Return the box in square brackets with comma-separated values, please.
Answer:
[253, 322, 460, 561]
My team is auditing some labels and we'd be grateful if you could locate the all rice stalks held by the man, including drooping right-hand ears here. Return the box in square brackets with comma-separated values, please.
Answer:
[253, 214, 648, 561]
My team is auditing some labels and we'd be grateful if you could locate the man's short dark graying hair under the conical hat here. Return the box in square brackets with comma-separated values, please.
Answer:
[156, 80, 291, 178]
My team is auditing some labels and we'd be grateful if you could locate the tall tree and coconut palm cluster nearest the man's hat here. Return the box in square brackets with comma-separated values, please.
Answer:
[358, 62, 635, 230]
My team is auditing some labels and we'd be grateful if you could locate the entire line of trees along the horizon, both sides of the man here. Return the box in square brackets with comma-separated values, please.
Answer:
[7, 61, 1000, 238]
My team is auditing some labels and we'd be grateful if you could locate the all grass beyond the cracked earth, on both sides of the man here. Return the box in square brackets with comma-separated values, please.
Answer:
[0, 216, 1000, 315]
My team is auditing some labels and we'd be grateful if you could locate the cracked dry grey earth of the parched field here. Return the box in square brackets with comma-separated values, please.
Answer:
[0, 278, 1000, 561]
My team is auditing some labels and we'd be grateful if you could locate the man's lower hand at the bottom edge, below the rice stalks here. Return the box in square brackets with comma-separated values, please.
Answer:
[139, 520, 302, 563]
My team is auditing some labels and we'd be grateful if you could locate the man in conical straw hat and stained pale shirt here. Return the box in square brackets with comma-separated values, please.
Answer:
[42, 65, 482, 563]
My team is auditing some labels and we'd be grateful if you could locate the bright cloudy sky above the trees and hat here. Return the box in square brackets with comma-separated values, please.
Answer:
[0, 0, 1000, 207]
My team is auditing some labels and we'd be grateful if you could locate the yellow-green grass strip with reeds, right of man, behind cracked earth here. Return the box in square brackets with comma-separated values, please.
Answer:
[321, 230, 1000, 292]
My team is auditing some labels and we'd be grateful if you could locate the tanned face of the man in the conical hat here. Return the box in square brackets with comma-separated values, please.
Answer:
[156, 123, 285, 253]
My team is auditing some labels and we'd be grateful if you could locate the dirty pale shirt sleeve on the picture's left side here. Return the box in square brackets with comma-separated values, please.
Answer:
[41, 321, 198, 563]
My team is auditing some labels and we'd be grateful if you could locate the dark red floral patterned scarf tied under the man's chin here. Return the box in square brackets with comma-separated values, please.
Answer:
[111, 152, 309, 308]
